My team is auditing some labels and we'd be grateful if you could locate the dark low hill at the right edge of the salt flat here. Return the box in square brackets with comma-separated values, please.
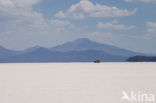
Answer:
[127, 56, 156, 62]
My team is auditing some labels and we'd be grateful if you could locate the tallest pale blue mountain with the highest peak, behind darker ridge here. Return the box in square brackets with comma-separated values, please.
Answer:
[50, 38, 142, 57]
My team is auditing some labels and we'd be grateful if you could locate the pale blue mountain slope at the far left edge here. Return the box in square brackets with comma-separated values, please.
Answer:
[0, 46, 21, 58]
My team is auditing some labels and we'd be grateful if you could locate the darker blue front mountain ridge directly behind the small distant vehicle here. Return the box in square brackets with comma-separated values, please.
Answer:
[0, 48, 127, 63]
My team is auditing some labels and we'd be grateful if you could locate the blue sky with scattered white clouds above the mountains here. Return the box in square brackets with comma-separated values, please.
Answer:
[0, 0, 156, 53]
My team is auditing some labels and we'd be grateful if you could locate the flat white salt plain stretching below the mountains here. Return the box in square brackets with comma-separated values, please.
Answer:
[0, 63, 156, 103]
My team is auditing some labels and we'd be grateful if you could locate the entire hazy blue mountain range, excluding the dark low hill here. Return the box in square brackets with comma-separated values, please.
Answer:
[0, 38, 149, 63]
